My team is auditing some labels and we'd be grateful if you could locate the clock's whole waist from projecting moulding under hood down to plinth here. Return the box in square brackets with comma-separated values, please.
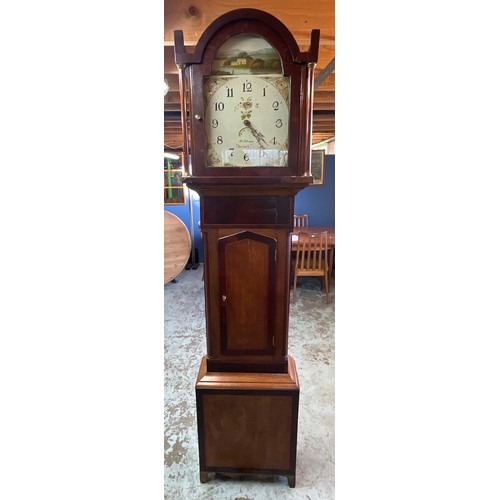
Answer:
[180, 182, 307, 373]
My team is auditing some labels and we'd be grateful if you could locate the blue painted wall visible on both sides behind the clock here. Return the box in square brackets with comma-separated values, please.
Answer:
[165, 155, 335, 262]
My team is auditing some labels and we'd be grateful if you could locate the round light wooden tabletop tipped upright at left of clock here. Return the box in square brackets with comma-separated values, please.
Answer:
[163, 212, 191, 283]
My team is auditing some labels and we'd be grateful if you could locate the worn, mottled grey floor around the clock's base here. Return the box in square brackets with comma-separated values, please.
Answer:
[165, 266, 335, 500]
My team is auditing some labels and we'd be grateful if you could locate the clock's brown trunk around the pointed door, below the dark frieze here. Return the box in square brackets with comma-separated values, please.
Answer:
[201, 225, 291, 372]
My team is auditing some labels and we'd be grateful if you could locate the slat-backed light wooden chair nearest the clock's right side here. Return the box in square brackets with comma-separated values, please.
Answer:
[293, 231, 330, 304]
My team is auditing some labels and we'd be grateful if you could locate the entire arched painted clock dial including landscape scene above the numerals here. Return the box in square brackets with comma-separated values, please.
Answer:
[203, 35, 290, 167]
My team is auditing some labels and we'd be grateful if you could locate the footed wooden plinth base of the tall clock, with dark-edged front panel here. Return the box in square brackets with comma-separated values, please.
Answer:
[196, 356, 299, 488]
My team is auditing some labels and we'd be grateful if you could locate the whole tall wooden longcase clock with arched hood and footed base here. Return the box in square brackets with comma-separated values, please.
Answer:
[174, 9, 319, 487]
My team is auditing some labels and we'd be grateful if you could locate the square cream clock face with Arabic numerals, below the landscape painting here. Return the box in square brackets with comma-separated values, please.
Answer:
[203, 74, 290, 167]
